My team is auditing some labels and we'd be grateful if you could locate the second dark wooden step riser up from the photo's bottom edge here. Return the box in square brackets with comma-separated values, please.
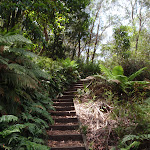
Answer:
[49, 134, 83, 141]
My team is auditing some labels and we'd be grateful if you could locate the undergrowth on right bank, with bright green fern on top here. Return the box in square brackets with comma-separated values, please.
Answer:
[86, 66, 150, 150]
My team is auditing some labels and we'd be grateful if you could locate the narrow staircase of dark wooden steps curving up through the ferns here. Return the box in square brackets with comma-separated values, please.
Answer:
[47, 80, 88, 150]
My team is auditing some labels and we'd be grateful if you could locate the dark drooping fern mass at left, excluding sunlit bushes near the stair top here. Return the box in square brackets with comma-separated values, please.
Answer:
[0, 36, 53, 149]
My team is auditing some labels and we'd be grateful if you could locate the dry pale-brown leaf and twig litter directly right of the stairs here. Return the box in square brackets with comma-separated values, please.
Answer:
[74, 91, 119, 150]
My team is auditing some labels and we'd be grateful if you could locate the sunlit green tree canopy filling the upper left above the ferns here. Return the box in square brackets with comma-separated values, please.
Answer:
[0, 0, 90, 59]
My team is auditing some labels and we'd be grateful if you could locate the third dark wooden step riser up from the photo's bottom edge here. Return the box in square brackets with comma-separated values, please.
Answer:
[49, 124, 79, 131]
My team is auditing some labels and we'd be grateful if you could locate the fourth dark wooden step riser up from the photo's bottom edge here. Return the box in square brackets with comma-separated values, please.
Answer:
[54, 118, 78, 123]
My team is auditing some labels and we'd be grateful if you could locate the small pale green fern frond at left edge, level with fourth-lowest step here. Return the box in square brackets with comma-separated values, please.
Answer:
[0, 115, 18, 123]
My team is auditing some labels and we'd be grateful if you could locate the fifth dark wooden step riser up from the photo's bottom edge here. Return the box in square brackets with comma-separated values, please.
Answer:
[50, 111, 76, 116]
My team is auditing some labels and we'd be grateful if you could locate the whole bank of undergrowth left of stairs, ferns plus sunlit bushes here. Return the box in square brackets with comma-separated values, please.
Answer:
[0, 35, 78, 150]
